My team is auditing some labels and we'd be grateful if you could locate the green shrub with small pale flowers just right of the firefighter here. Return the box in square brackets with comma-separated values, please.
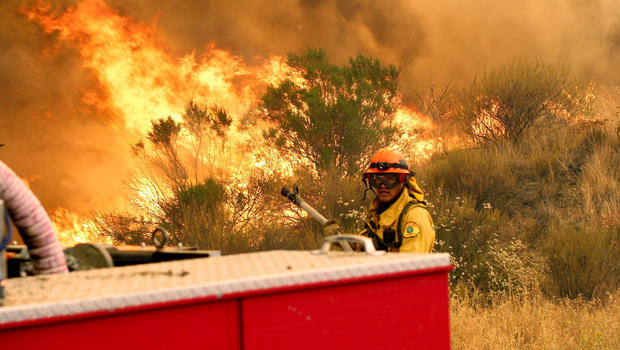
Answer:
[430, 193, 538, 295]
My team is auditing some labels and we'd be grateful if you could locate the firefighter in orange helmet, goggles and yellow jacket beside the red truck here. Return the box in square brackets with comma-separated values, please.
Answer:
[323, 148, 435, 253]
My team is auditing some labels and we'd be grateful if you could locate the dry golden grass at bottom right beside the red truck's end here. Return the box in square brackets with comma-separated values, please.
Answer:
[450, 291, 620, 350]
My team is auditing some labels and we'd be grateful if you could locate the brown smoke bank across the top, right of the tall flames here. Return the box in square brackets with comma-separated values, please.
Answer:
[103, 0, 620, 86]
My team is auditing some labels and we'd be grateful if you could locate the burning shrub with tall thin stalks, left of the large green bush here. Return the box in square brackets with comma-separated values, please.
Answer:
[100, 102, 245, 249]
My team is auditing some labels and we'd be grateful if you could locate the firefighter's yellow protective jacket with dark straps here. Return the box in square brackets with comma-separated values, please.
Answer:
[360, 180, 435, 253]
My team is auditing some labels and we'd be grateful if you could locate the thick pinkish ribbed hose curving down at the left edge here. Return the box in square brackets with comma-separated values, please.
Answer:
[0, 161, 68, 274]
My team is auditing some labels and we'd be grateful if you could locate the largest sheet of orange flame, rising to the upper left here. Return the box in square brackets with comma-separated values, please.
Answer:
[22, 0, 289, 131]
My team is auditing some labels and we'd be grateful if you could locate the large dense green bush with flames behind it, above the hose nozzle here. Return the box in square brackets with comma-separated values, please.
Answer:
[259, 49, 400, 175]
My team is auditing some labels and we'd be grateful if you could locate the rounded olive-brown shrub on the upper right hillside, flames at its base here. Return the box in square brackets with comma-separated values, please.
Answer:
[456, 61, 594, 143]
